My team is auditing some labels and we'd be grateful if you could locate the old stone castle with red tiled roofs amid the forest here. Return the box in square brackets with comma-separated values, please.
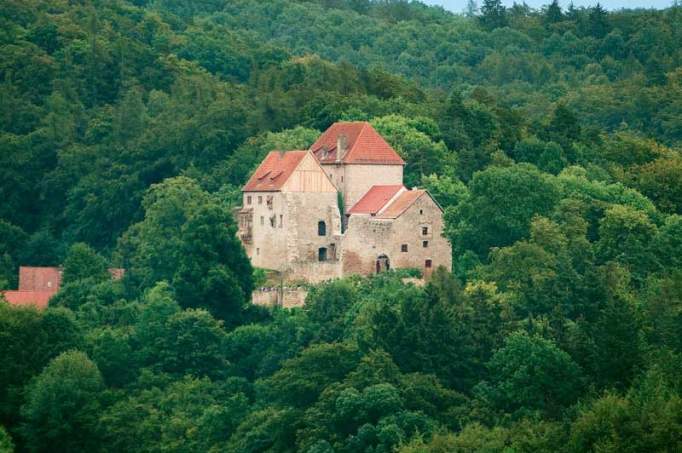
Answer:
[235, 122, 452, 282]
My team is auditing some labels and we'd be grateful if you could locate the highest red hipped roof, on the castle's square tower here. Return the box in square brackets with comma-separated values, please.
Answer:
[310, 121, 405, 165]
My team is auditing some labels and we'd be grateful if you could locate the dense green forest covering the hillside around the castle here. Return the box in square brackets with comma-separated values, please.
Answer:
[0, 0, 682, 453]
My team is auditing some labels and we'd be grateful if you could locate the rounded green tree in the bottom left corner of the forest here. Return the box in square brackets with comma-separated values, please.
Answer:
[21, 351, 104, 452]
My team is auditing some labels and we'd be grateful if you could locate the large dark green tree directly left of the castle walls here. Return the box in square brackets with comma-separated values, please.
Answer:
[119, 177, 253, 325]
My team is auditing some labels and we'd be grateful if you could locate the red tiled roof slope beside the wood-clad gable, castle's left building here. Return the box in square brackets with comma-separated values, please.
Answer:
[242, 151, 307, 192]
